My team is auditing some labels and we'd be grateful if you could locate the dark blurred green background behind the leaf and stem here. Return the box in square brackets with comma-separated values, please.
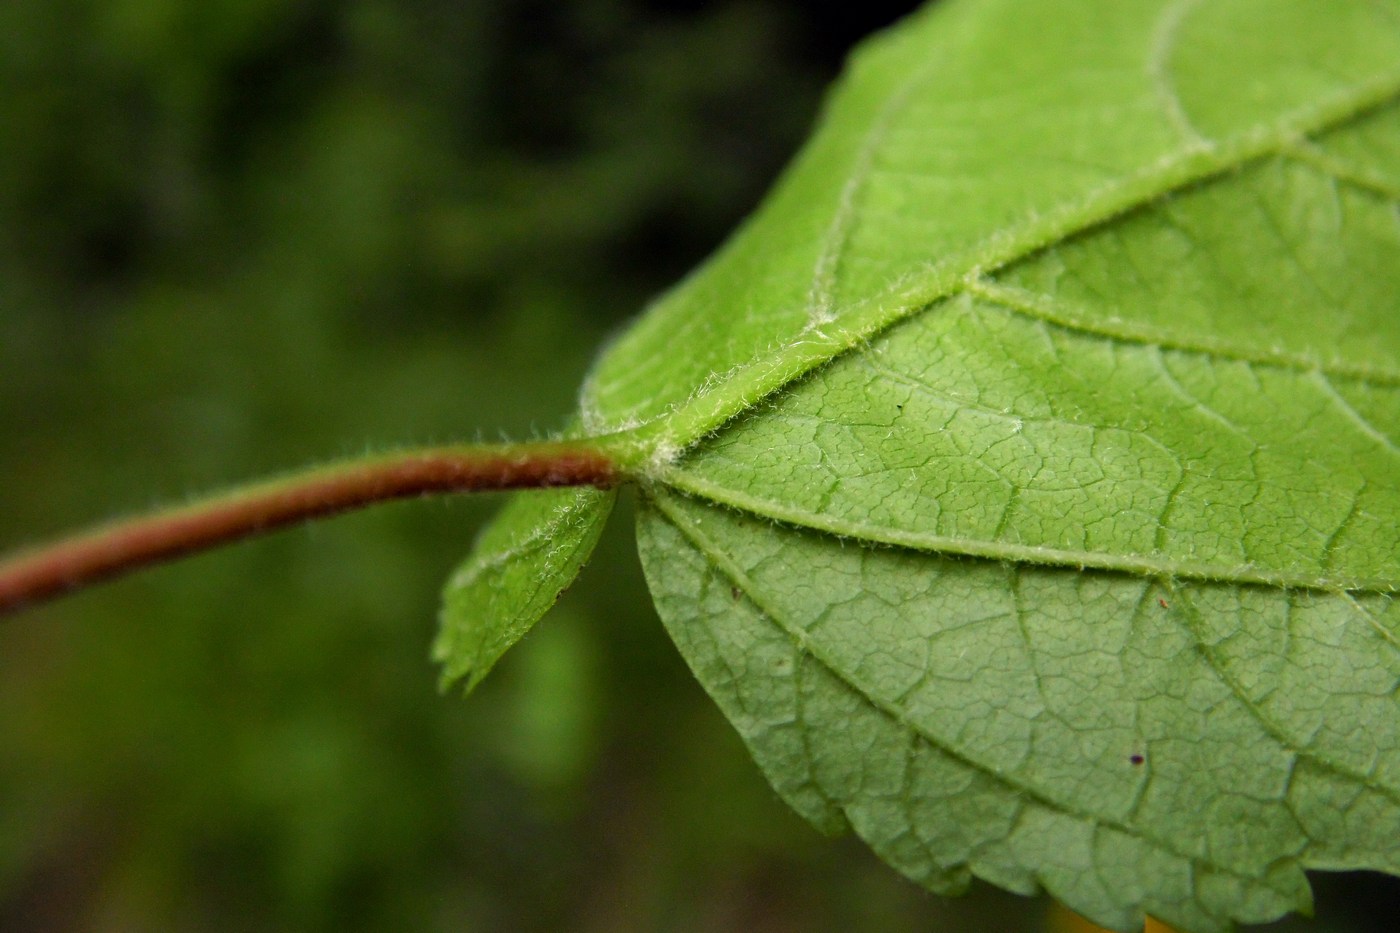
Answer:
[0, 0, 1393, 930]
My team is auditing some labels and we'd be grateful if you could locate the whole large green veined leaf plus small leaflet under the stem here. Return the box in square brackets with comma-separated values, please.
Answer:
[444, 0, 1400, 933]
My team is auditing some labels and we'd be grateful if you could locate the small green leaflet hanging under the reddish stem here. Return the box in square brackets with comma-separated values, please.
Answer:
[433, 486, 617, 691]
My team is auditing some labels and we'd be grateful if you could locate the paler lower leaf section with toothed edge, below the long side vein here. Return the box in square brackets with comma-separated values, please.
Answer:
[640, 493, 1400, 930]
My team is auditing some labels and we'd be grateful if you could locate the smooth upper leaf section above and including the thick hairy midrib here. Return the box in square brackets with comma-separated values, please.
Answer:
[584, 0, 1400, 451]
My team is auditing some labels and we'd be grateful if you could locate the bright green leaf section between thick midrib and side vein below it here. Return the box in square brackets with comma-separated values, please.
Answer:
[664, 150, 1400, 588]
